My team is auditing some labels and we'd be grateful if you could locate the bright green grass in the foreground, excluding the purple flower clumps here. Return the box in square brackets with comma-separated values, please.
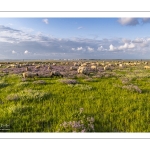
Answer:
[0, 66, 150, 132]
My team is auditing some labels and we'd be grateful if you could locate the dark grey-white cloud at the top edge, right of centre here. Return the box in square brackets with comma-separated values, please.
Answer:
[118, 18, 139, 26]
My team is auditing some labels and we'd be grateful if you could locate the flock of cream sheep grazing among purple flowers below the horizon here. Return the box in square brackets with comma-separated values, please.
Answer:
[0, 61, 150, 78]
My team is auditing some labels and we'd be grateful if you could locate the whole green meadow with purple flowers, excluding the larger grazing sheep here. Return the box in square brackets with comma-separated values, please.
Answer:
[0, 60, 150, 132]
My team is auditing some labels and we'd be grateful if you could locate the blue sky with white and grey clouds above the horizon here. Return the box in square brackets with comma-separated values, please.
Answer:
[0, 18, 150, 59]
